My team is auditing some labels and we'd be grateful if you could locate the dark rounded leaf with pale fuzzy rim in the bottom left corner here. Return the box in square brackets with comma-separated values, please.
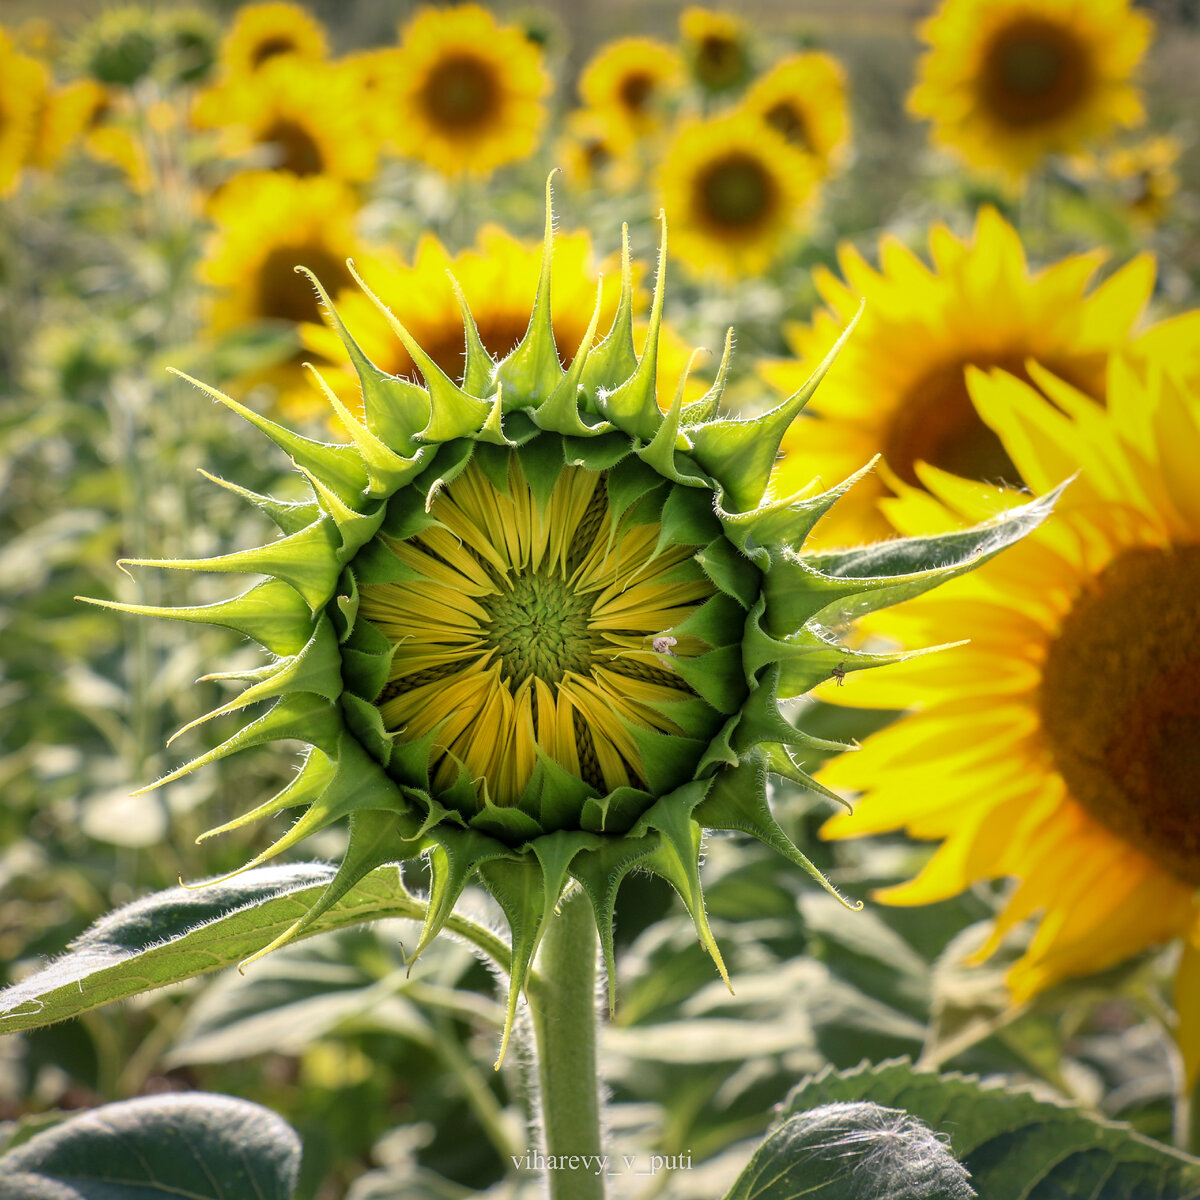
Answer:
[0, 1092, 300, 1200]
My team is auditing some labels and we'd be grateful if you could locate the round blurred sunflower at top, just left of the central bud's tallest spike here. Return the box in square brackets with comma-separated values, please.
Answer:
[392, 4, 550, 176]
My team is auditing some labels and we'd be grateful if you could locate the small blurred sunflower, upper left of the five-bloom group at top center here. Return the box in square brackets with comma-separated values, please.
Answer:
[580, 37, 683, 137]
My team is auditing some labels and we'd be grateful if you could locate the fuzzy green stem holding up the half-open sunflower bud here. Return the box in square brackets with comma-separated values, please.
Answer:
[529, 892, 605, 1200]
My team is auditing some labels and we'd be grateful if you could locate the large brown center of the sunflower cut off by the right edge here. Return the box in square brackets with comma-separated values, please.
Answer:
[1040, 546, 1200, 884]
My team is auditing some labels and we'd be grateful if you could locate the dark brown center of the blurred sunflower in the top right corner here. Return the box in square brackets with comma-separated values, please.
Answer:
[982, 17, 1091, 125]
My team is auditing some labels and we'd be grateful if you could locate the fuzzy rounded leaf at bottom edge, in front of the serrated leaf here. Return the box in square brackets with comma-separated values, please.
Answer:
[726, 1102, 976, 1200]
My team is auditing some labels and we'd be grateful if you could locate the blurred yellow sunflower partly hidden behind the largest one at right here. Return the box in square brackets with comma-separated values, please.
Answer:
[761, 209, 1154, 546]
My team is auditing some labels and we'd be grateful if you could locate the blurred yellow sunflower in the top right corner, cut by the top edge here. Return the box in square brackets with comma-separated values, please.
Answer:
[908, 0, 1154, 179]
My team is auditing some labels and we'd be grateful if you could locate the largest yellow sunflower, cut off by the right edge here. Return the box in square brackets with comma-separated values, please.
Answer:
[821, 358, 1200, 1081]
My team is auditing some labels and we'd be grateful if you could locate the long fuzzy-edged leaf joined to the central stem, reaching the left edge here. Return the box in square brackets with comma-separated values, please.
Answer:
[0, 863, 425, 1033]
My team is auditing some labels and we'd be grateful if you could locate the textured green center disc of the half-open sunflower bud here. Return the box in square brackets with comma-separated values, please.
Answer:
[482, 571, 598, 686]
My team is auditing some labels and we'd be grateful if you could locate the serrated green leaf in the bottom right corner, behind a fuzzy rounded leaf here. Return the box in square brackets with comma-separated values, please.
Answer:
[784, 1060, 1200, 1200]
